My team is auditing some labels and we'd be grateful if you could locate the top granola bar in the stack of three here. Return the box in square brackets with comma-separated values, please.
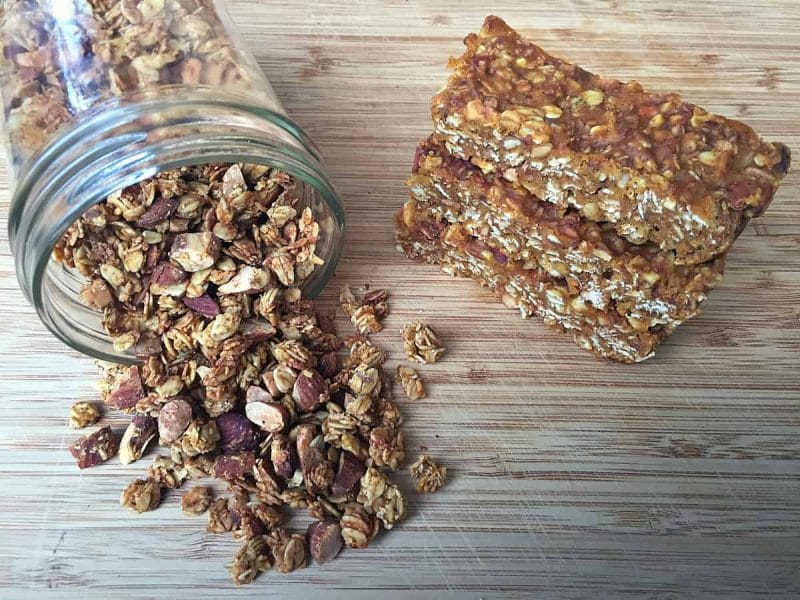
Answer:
[431, 16, 790, 264]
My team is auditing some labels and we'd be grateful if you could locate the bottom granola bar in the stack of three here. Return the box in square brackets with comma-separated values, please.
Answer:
[397, 200, 673, 363]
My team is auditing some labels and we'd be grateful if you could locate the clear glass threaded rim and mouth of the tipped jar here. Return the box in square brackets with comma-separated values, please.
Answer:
[8, 89, 345, 363]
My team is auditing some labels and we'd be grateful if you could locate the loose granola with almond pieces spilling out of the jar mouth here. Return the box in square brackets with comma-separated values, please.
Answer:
[62, 164, 441, 584]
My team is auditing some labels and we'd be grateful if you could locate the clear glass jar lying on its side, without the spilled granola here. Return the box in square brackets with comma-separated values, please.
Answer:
[0, 0, 344, 362]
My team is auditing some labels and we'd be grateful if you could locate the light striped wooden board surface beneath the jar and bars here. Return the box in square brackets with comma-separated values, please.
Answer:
[0, 0, 800, 600]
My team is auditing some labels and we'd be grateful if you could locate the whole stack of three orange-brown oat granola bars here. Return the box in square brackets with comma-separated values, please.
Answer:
[397, 17, 789, 362]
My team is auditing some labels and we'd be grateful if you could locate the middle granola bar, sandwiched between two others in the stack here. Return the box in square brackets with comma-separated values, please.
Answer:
[406, 143, 724, 327]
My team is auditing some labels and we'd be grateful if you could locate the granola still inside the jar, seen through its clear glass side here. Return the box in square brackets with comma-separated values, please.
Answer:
[0, 0, 266, 166]
